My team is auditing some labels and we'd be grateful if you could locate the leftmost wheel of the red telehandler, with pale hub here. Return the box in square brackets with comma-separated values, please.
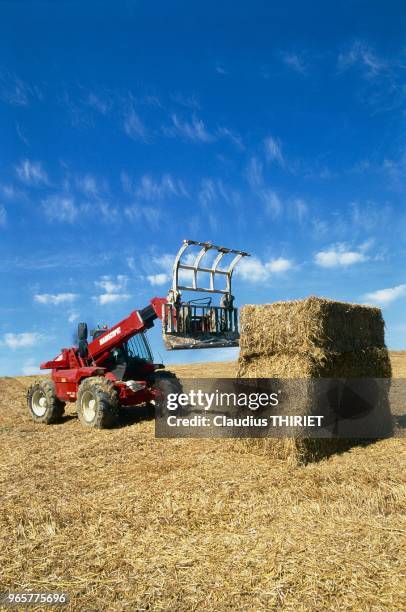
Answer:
[27, 380, 65, 425]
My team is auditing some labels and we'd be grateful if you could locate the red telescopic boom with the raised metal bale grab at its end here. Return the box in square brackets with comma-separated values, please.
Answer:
[41, 240, 249, 370]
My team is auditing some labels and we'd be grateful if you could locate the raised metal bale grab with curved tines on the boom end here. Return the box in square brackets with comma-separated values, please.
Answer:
[162, 240, 249, 350]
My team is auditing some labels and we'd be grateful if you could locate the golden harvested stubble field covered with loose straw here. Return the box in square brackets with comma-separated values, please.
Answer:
[0, 353, 406, 611]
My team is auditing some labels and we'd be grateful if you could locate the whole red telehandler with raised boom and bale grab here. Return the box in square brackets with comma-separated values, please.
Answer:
[27, 240, 249, 428]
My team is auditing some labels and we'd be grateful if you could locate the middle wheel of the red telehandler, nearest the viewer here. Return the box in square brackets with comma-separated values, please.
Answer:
[77, 376, 120, 429]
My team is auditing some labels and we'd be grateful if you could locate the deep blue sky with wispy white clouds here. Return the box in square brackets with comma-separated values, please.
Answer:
[0, 1, 406, 375]
